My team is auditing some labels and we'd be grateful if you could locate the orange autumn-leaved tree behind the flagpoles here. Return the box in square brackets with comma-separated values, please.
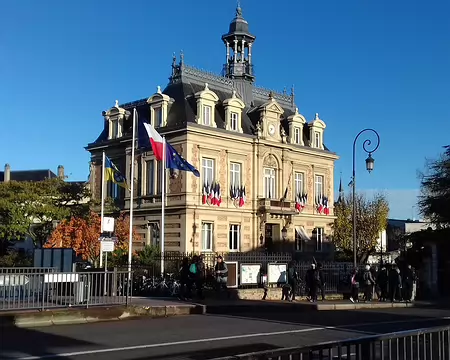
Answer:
[44, 212, 139, 263]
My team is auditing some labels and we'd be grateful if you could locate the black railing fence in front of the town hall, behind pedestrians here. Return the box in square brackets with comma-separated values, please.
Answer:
[123, 252, 363, 294]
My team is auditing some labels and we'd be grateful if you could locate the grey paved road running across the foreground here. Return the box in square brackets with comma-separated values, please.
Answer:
[0, 308, 450, 360]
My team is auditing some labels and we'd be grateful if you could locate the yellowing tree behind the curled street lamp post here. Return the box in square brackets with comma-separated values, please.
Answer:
[332, 194, 389, 263]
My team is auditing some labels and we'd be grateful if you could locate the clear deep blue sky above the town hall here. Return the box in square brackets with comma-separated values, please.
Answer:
[0, 0, 450, 218]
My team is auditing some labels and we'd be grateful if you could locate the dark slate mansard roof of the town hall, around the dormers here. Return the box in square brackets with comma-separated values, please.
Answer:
[88, 63, 329, 151]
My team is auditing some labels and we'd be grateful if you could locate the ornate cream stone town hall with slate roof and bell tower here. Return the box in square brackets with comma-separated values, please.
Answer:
[86, 3, 338, 259]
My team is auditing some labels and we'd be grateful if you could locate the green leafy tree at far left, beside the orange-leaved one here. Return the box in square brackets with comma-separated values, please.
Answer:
[0, 178, 90, 250]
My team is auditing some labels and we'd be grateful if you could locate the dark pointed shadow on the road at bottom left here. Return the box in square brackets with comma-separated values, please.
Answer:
[0, 315, 91, 360]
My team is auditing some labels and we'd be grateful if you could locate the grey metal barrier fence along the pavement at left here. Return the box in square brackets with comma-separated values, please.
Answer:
[0, 271, 131, 311]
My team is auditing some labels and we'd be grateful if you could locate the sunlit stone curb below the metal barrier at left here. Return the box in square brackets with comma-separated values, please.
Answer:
[0, 304, 206, 328]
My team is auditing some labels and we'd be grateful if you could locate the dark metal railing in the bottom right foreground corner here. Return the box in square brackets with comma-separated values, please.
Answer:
[214, 327, 450, 360]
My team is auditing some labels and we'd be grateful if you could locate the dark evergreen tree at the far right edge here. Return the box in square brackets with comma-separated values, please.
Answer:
[419, 145, 450, 228]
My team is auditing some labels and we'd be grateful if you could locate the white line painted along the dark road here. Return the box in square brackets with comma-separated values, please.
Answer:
[16, 316, 450, 360]
